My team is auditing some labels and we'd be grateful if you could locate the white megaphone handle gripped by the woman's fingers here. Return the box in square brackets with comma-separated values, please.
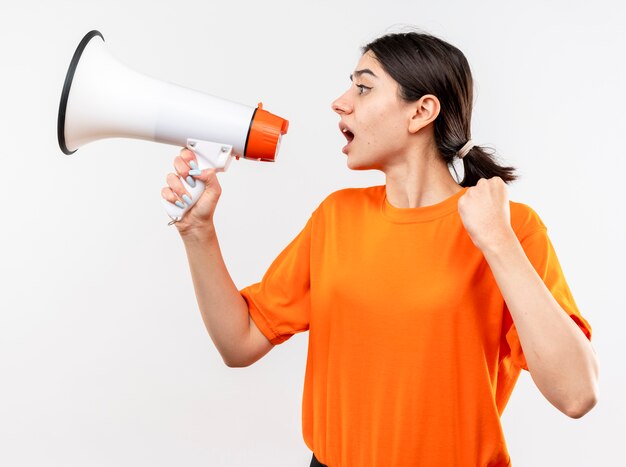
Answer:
[161, 138, 233, 222]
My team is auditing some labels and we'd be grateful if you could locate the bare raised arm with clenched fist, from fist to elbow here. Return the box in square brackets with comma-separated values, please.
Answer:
[458, 177, 599, 418]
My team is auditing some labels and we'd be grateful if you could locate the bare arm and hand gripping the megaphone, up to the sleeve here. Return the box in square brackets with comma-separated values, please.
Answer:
[161, 149, 273, 367]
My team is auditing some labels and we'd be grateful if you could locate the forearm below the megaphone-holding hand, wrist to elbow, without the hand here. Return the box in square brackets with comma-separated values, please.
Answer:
[182, 225, 250, 366]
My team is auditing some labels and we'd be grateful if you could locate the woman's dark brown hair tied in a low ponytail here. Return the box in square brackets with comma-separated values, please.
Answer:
[362, 31, 518, 187]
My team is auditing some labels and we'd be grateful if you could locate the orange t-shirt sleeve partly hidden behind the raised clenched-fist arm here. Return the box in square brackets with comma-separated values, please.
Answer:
[504, 226, 591, 371]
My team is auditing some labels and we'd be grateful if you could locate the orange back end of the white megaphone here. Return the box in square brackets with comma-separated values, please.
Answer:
[243, 102, 289, 162]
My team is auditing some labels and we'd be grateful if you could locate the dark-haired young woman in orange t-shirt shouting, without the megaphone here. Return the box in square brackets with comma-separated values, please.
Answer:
[162, 32, 597, 467]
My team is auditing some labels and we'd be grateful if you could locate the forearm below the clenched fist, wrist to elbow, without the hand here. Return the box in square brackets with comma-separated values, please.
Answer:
[483, 232, 598, 418]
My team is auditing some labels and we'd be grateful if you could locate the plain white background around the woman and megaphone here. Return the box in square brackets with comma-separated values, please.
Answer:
[0, 0, 626, 467]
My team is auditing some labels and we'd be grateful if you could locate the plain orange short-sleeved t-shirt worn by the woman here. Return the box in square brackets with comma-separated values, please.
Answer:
[241, 186, 591, 467]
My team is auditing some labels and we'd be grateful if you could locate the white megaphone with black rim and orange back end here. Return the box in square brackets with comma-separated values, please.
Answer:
[57, 30, 289, 222]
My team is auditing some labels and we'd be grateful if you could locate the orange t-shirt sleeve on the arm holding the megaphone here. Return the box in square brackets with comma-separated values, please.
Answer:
[240, 216, 313, 345]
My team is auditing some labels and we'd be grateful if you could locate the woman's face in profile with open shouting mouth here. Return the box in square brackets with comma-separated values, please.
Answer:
[332, 51, 414, 170]
